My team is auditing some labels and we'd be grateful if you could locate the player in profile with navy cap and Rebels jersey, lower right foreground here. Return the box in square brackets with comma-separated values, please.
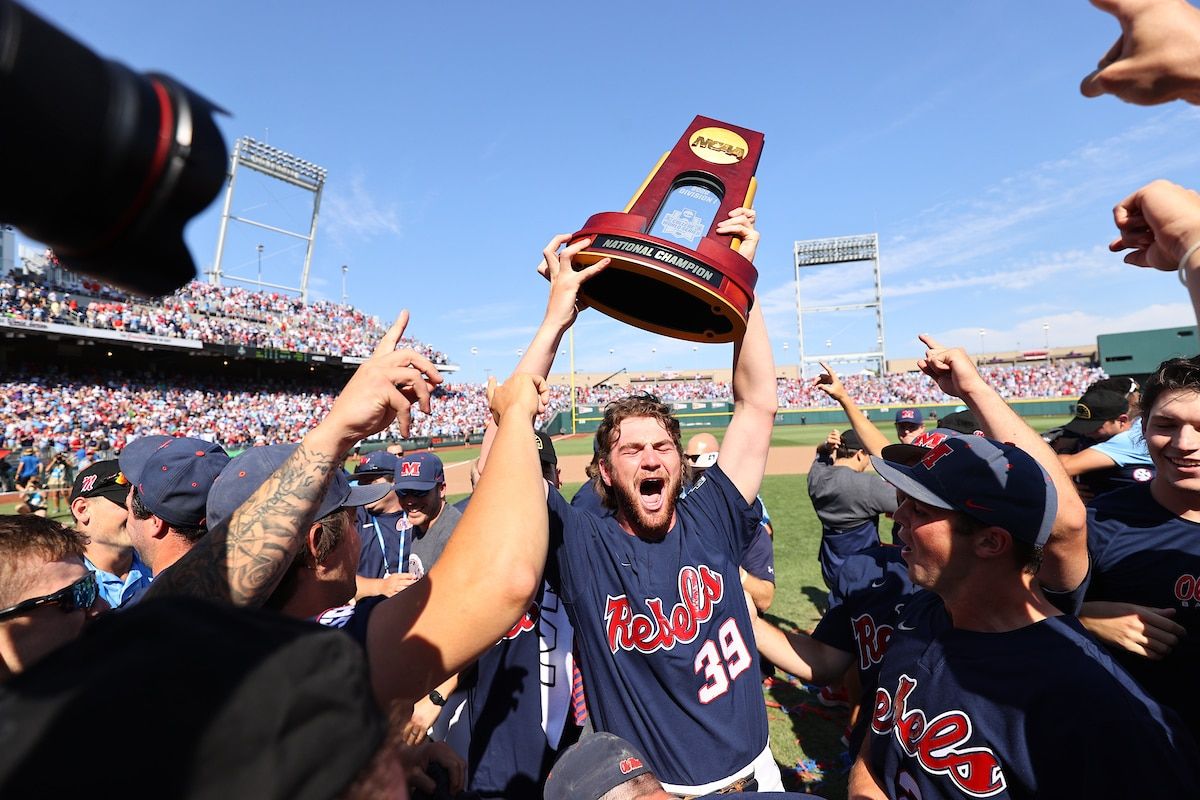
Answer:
[851, 337, 1200, 798]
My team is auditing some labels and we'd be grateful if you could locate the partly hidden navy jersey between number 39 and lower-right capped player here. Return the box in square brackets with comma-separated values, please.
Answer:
[812, 545, 923, 753]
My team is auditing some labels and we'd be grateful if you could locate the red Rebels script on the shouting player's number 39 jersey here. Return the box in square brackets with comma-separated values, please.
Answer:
[604, 564, 725, 654]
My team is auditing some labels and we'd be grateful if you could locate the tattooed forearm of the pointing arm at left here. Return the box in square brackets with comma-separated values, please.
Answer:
[226, 441, 340, 606]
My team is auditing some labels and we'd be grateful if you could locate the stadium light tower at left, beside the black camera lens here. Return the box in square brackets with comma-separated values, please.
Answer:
[209, 137, 328, 302]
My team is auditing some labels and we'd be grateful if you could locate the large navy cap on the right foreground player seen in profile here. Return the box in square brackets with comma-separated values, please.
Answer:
[871, 435, 1058, 547]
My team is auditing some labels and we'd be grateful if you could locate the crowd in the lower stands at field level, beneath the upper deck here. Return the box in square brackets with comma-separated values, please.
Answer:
[0, 363, 1104, 460]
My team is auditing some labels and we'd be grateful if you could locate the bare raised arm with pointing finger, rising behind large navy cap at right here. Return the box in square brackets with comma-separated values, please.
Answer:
[917, 335, 1087, 591]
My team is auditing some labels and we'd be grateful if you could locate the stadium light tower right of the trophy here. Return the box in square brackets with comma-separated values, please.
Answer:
[793, 234, 887, 379]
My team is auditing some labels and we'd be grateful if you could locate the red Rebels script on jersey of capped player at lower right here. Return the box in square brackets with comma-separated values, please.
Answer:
[871, 675, 1008, 798]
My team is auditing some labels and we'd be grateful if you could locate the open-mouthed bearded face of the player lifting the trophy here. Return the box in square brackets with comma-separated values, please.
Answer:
[600, 416, 683, 539]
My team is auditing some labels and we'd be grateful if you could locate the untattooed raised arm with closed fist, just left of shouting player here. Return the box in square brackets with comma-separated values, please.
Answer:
[367, 375, 550, 703]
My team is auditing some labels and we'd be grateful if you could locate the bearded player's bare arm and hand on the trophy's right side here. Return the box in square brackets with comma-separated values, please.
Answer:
[716, 209, 779, 503]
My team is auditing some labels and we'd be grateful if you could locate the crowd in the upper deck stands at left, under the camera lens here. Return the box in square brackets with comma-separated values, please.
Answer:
[0, 276, 449, 363]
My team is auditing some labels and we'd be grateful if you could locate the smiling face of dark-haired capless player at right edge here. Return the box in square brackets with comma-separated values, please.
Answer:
[1144, 389, 1200, 492]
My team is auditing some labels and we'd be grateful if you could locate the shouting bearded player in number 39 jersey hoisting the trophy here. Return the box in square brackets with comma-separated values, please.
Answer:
[508, 209, 782, 795]
